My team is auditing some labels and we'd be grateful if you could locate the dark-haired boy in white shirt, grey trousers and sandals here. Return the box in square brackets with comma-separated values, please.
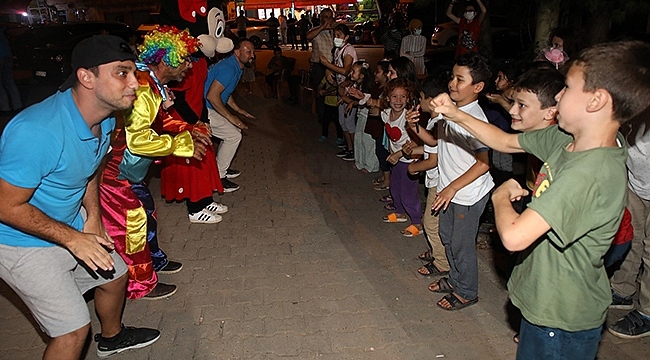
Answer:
[407, 53, 494, 310]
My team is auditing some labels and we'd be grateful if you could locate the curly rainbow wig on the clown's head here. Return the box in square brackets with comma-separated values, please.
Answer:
[138, 25, 200, 68]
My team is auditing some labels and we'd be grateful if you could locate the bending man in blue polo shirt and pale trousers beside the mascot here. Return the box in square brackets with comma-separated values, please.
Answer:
[205, 39, 255, 192]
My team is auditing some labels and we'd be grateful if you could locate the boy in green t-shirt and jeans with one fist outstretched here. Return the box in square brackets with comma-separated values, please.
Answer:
[431, 41, 650, 360]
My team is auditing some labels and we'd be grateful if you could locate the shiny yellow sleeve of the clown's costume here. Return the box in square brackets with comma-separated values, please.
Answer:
[124, 85, 194, 157]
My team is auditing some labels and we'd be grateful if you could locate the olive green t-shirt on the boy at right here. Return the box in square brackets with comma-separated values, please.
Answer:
[508, 125, 627, 331]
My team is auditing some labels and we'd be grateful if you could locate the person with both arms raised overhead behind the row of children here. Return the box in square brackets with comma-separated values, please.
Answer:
[447, 0, 487, 57]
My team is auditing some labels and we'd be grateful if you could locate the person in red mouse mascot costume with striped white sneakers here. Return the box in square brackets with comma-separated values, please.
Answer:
[161, 0, 233, 224]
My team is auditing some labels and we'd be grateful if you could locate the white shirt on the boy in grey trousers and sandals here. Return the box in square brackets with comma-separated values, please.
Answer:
[436, 100, 494, 206]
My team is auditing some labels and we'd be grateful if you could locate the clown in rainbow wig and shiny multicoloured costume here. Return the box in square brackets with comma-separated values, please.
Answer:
[100, 26, 211, 299]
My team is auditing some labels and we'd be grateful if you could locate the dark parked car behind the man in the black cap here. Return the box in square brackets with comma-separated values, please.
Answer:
[19, 22, 134, 81]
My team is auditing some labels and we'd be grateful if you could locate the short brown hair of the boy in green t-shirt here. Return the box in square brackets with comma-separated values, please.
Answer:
[572, 41, 650, 123]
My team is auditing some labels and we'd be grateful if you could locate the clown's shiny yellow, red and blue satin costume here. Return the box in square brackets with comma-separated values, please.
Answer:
[100, 71, 194, 299]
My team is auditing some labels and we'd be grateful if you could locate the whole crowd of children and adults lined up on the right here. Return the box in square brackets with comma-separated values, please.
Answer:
[298, 0, 650, 359]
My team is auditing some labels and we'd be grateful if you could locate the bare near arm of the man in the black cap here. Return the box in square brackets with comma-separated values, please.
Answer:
[0, 179, 114, 271]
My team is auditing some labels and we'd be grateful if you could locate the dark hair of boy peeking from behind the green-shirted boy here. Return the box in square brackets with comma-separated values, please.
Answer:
[514, 68, 564, 109]
